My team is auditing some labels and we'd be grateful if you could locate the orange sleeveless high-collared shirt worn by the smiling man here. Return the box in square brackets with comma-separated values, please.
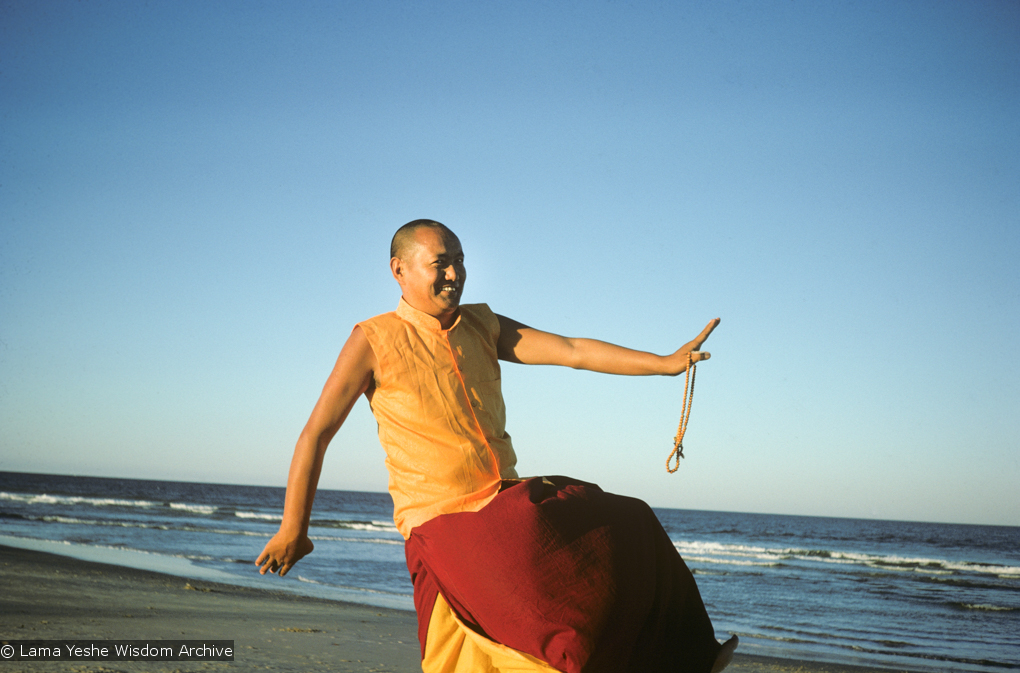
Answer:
[358, 299, 517, 539]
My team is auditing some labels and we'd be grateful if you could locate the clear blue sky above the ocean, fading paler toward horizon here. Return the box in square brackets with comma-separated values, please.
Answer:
[0, 0, 1020, 525]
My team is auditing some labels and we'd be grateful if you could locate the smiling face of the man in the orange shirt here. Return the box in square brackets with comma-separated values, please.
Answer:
[390, 226, 467, 329]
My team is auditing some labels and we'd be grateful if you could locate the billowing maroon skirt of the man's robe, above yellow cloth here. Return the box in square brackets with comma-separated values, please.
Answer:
[405, 477, 720, 673]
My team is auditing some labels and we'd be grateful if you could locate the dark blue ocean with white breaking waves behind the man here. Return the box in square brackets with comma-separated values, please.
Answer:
[0, 472, 1020, 672]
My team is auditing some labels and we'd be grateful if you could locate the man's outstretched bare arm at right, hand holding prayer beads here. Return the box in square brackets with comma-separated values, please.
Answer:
[497, 315, 719, 376]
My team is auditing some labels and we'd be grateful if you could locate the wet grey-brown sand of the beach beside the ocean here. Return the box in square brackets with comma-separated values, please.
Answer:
[0, 547, 909, 673]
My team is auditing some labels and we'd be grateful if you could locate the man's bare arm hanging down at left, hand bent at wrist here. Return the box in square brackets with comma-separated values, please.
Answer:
[255, 327, 375, 576]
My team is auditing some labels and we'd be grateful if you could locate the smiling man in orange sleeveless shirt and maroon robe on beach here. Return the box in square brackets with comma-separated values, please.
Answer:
[256, 220, 736, 673]
